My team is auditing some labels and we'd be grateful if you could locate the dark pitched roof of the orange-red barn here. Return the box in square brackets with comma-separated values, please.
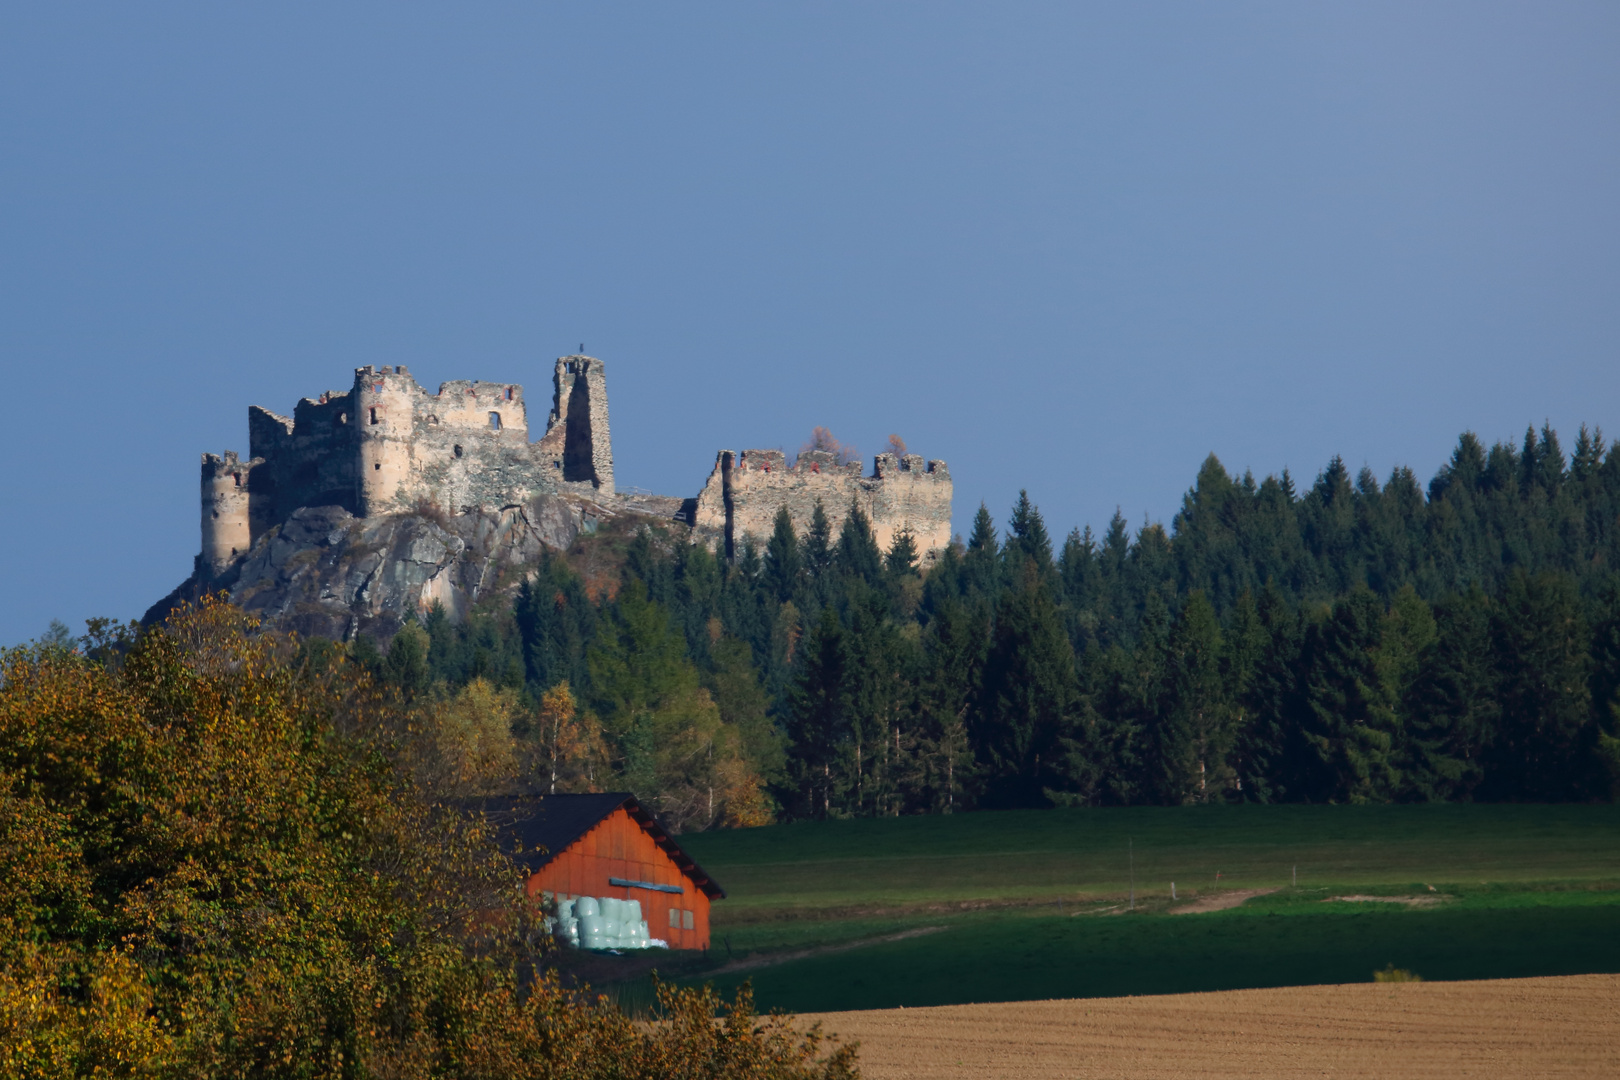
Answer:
[468, 792, 726, 900]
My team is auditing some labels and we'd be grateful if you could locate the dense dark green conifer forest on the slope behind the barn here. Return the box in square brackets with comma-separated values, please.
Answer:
[350, 427, 1620, 829]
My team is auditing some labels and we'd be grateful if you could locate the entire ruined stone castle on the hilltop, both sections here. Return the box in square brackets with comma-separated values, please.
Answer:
[198, 355, 951, 586]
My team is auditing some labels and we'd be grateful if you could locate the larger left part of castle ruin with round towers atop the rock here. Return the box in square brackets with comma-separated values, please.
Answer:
[201, 356, 614, 575]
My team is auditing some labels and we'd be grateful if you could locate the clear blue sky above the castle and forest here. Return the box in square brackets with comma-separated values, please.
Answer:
[0, 2, 1620, 641]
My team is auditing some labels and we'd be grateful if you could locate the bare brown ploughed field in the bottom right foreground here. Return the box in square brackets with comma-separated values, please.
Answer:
[802, 975, 1620, 1080]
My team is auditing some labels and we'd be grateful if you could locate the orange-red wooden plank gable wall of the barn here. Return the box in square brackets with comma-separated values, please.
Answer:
[528, 810, 710, 949]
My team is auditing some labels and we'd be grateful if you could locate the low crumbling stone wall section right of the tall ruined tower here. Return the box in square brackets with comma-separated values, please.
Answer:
[692, 450, 951, 560]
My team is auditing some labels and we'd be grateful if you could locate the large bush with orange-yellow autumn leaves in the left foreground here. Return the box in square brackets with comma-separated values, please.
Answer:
[0, 602, 855, 1080]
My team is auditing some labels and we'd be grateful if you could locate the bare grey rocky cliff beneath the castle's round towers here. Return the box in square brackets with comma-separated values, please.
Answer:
[143, 494, 641, 643]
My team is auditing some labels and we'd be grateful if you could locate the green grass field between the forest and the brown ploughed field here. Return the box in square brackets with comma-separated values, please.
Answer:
[638, 805, 1620, 1012]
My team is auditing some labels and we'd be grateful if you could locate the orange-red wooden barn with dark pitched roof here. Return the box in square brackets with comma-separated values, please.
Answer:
[480, 792, 726, 949]
